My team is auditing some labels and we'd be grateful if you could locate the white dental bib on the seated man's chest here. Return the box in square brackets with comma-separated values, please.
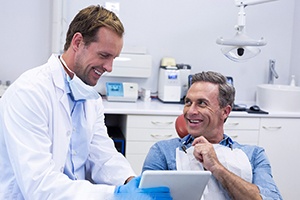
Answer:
[176, 144, 252, 200]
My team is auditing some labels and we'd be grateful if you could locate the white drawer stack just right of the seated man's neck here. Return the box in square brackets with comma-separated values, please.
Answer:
[224, 117, 259, 145]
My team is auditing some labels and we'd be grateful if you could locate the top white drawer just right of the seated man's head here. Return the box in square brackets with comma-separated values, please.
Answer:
[224, 117, 259, 130]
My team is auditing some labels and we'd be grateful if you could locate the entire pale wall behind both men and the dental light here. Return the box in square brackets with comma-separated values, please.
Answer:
[0, 0, 300, 105]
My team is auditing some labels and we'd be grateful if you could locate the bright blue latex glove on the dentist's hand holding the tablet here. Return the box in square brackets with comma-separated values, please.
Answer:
[114, 176, 172, 200]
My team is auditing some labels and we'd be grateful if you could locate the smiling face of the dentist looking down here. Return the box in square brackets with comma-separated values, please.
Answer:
[74, 27, 123, 86]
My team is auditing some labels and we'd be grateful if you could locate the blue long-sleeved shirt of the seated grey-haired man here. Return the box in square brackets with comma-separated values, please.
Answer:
[143, 134, 282, 199]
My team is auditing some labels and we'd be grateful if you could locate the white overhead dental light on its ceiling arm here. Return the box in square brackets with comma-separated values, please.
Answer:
[216, 0, 276, 62]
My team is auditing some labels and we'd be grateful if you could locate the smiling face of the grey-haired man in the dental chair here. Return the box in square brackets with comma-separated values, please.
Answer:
[183, 82, 227, 143]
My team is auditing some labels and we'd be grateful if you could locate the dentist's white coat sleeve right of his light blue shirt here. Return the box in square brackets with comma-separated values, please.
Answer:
[88, 99, 135, 185]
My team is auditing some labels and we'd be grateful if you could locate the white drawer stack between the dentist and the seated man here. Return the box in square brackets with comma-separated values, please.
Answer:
[126, 115, 178, 174]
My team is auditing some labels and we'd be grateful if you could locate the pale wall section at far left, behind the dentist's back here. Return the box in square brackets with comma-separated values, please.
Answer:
[0, 0, 52, 81]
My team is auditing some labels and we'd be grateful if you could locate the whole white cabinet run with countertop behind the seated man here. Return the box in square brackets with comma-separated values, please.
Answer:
[105, 101, 300, 200]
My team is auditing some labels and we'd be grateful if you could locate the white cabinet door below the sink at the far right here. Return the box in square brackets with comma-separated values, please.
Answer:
[259, 118, 300, 200]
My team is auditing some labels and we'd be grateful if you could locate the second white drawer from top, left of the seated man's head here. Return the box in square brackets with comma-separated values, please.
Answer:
[127, 128, 178, 142]
